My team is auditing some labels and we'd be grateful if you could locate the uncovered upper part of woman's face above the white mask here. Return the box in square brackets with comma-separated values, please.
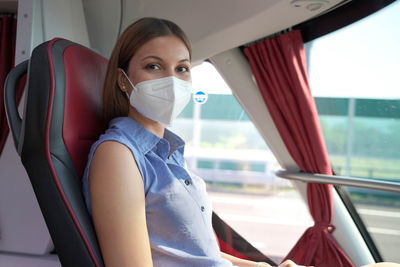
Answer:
[127, 36, 191, 93]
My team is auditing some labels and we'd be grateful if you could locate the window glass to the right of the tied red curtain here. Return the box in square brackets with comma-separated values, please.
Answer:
[305, 1, 400, 262]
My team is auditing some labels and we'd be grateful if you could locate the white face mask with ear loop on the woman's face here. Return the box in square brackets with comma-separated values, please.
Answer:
[122, 70, 192, 127]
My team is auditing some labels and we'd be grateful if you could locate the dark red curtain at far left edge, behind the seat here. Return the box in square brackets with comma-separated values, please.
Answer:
[0, 15, 18, 155]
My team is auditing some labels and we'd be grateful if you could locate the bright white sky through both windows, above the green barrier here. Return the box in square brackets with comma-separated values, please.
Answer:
[192, 1, 400, 99]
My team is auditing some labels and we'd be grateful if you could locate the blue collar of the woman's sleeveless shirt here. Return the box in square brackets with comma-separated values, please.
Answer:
[109, 117, 185, 156]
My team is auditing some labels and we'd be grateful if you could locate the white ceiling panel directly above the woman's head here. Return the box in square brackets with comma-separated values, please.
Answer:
[122, 0, 342, 62]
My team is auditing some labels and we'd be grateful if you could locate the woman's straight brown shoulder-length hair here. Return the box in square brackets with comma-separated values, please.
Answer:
[103, 18, 192, 123]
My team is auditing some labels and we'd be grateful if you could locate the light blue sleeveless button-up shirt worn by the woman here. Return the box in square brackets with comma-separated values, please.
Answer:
[82, 117, 232, 267]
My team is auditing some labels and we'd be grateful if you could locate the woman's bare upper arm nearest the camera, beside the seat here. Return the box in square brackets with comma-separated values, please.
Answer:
[89, 141, 152, 267]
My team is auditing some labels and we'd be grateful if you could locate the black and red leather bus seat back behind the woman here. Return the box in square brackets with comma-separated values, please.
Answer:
[5, 39, 107, 267]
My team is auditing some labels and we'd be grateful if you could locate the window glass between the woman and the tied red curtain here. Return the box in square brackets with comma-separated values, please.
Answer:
[172, 62, 313, 262]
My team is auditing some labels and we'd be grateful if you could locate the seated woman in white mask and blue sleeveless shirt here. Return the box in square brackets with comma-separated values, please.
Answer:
[83, 18, 304, 267]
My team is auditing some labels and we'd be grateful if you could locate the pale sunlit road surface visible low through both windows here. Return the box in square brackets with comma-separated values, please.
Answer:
[209, 190, 400, 262]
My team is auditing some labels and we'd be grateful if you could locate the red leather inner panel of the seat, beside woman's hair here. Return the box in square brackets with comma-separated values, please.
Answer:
[59, 45, 107, 177]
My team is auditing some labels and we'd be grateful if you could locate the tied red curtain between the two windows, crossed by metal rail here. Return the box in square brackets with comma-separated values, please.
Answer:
[244, 31, 353, 267]
